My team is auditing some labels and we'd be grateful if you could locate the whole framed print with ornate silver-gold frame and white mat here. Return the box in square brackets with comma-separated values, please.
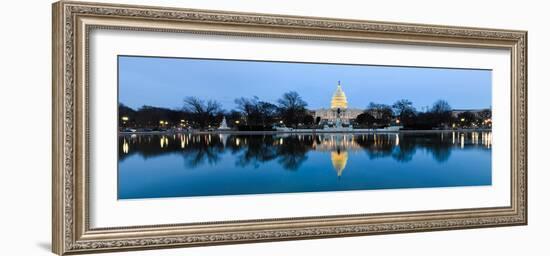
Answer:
[52, 1, 527, 255]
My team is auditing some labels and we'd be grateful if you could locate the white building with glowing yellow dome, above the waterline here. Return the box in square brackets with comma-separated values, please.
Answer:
[314, 81, 363, 127]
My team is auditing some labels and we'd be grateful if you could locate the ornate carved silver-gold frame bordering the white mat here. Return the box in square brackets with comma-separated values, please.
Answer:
[52, 1, 527, 255]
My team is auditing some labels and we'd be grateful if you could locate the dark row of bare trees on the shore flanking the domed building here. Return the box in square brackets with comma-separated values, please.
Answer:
[119, 91, 491, 130]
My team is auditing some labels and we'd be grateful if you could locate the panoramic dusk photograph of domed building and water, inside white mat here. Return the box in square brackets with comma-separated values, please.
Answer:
[117, 55, 492, 200]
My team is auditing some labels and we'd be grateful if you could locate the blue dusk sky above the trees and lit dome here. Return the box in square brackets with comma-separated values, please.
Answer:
[119, 56, 491, 111]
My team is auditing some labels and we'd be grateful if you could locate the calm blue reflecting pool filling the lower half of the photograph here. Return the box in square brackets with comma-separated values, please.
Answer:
[118, 132, 492, 199]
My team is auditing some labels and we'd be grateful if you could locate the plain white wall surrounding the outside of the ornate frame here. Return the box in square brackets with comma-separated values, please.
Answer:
[0, 0, 550, 256]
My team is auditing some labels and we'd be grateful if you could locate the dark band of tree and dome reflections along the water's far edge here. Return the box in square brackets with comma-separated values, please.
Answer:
[118, 132, 492, 175]
